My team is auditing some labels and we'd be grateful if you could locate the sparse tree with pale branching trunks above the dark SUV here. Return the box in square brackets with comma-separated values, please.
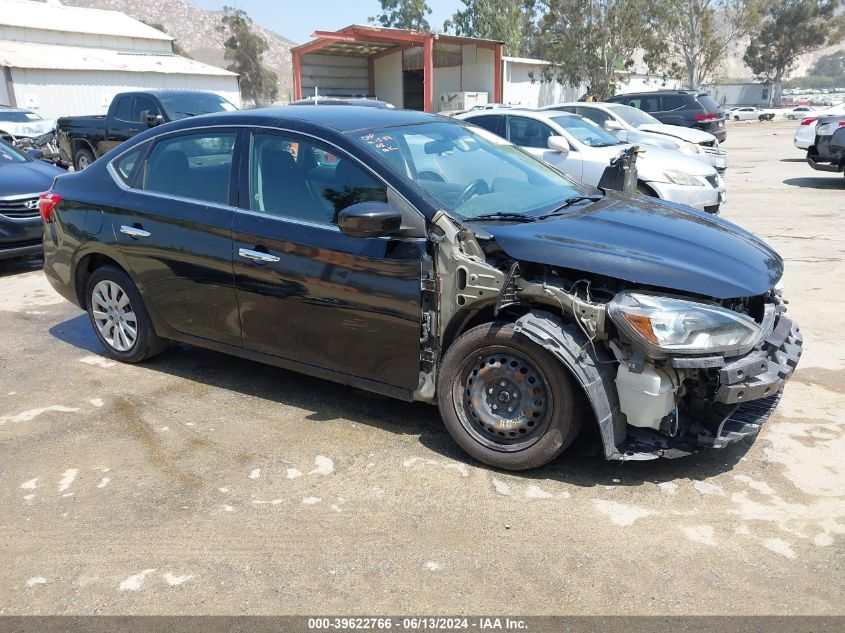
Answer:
[648, 0, 759, 89]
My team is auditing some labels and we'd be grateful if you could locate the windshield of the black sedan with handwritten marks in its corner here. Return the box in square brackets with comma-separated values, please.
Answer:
[352, 122, 598, 220]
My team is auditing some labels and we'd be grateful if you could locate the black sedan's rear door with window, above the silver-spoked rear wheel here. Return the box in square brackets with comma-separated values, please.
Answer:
[113, 128, 241, 346]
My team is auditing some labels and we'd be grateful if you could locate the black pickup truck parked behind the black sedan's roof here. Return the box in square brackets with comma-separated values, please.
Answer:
[56, 90, 236, 171]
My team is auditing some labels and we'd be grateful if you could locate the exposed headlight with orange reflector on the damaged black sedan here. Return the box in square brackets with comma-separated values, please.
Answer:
[608, 292, 762, 357]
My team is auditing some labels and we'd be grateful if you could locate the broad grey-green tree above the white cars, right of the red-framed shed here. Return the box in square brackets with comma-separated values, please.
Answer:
[538, 0, 657, 100]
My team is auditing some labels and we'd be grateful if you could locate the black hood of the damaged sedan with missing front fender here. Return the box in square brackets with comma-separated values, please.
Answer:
[473, 193, 783, 299]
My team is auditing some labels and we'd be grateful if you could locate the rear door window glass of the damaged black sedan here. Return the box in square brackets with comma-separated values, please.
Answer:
[143, 130, 237, 205]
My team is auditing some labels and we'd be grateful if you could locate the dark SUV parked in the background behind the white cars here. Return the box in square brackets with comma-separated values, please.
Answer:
[608, 90, 728, 143]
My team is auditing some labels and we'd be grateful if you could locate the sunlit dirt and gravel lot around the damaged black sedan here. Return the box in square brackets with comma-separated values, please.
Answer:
[0, 121, 845, 615]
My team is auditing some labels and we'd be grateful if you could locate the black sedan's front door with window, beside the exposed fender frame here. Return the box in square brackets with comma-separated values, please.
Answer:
[233, 132, 425, 389]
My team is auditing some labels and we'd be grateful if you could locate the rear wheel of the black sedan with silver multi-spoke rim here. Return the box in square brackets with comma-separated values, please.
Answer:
[85, 266, 167, 363]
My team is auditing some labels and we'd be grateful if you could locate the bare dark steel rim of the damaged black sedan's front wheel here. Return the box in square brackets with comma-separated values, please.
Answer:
[452, 350, 549, 451]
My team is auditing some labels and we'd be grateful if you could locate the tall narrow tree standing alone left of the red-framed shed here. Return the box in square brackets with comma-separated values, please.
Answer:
[218, 7, 279, 107]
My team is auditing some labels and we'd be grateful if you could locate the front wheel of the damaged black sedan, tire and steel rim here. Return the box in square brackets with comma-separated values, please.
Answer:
[437, 322, 581, 470]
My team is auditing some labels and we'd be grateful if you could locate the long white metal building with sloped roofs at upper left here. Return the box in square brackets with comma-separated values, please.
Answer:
[0, 0, 241, 119]
